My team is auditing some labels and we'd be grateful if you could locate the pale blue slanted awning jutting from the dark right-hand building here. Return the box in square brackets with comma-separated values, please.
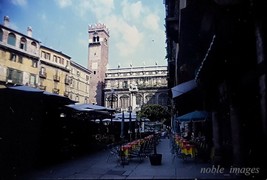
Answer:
[172, 79, 197, 98]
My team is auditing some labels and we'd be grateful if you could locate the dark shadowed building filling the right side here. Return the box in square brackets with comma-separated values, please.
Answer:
[164, 0, 267, 176]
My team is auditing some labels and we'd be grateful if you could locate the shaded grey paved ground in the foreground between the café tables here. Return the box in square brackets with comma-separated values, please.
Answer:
[24, 138, 238, 180]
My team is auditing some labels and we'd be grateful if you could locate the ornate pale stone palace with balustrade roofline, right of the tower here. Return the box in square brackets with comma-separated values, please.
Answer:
[104, 65, 169, 111]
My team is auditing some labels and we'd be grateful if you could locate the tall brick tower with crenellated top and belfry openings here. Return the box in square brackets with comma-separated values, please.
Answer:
[88, 24, 109, 106]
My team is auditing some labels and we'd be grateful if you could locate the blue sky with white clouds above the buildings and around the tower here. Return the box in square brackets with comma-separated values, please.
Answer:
[0, 0, 167, 68]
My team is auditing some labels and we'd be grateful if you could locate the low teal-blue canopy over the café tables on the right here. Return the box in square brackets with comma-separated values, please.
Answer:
[176, 111, 211, 122]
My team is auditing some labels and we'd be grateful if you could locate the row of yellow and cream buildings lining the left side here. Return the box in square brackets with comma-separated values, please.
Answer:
[0, 16, 91, 103]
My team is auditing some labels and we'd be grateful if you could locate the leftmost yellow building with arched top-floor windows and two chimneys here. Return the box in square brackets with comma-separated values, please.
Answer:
[0, 16, 40, 87]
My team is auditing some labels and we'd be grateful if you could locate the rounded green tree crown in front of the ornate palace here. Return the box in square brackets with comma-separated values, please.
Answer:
[139, 104, 170, 122]
